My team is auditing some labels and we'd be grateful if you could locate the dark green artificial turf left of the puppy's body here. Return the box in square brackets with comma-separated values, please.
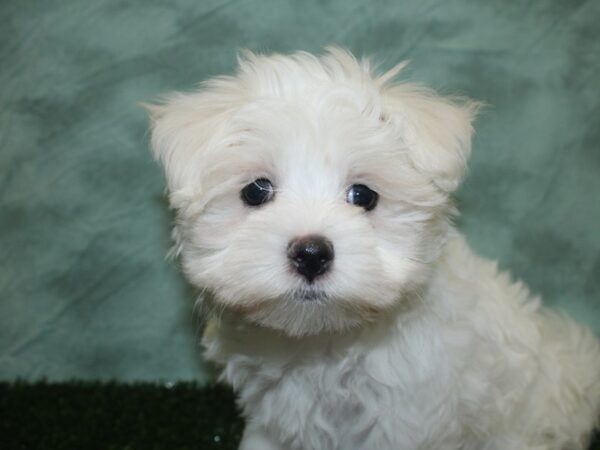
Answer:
[0, 382, 243, 450]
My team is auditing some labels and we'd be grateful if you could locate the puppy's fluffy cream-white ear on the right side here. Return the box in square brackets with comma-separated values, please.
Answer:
[382, 84, 481, 193]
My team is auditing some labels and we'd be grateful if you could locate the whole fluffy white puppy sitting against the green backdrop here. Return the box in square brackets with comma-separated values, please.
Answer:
[151, 49, 600, 450]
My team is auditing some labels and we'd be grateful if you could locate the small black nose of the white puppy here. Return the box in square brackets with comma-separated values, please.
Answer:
[288, 235, 333, 283]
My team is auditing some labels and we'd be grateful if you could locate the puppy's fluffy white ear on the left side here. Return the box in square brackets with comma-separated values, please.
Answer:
[143, 78, 238, 206]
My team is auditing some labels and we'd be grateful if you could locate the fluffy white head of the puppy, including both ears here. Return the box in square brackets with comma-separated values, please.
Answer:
[151, 49, 476, 336]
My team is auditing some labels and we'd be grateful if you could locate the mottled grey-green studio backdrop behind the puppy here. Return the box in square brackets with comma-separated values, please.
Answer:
[0, 0, 600, 380]
